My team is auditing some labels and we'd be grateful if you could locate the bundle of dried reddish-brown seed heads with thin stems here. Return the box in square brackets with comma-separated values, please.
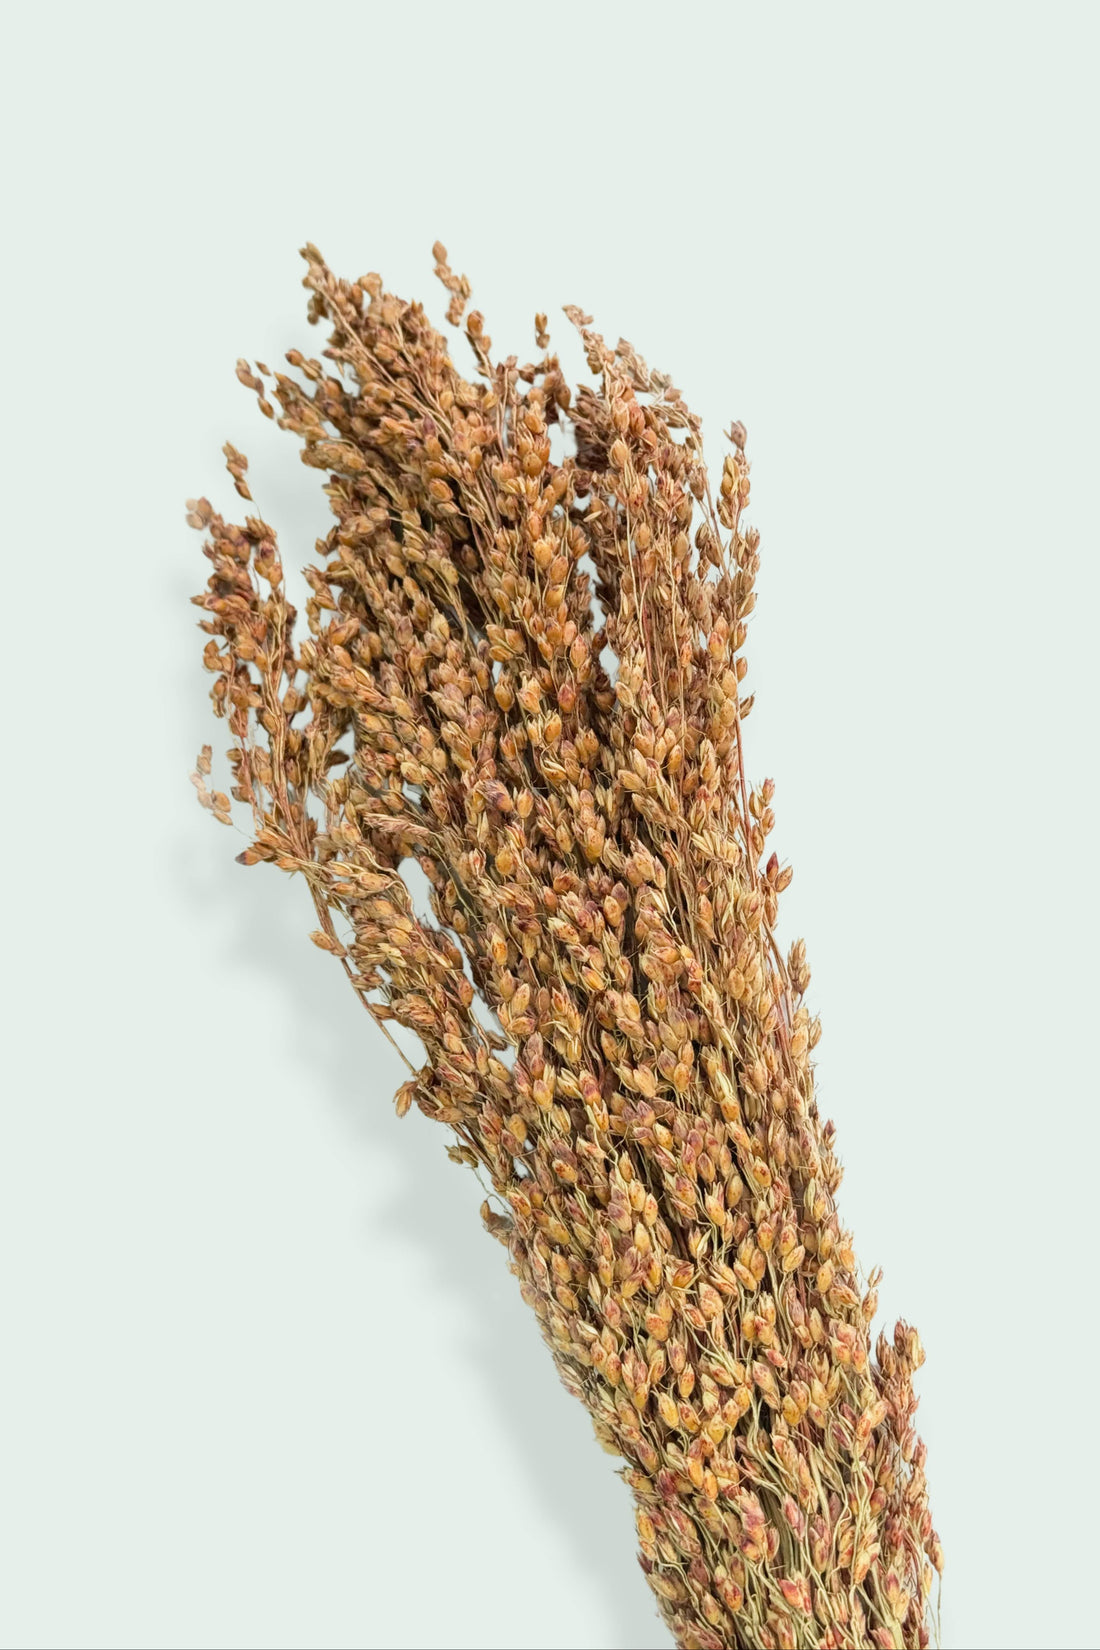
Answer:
[188, 244, 942, 1650]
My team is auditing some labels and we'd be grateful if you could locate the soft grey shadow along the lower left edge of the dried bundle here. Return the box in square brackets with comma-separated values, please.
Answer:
[176, 792, 671, 1650]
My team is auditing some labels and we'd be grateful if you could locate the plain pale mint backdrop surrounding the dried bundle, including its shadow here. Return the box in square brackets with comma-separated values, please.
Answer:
[0, 0, 1100, 1650]
